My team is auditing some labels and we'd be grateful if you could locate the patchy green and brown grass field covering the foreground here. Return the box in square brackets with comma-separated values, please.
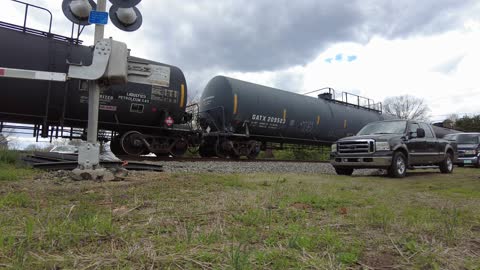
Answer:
[0, 167, 480, 270]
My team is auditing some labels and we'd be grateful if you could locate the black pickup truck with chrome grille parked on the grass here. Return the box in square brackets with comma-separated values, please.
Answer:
[330, 120, 456, 178]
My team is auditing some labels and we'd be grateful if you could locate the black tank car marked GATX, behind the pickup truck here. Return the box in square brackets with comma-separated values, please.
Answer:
[200, 76, 393, 158]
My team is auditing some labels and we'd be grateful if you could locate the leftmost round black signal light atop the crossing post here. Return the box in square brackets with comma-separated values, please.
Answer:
[62, 0, 97, 25]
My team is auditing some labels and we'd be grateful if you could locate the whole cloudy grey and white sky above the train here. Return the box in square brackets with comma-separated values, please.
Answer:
[0, 0, 480, 120]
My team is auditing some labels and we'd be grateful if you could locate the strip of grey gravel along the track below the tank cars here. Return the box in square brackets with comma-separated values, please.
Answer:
[152, 161, 379, 175]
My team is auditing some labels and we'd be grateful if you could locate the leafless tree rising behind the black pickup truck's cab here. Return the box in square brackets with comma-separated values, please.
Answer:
[383, 95, 430, 120]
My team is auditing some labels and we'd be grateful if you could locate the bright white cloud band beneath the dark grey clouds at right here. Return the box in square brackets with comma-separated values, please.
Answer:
[248, 26, 480, 120]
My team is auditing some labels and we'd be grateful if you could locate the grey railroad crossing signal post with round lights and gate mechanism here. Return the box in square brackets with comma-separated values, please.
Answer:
[62, 0, 142, 172]
